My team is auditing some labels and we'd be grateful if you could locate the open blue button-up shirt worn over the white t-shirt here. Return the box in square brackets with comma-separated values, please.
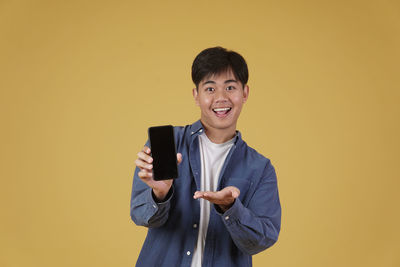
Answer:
[131, 121, 281, 267]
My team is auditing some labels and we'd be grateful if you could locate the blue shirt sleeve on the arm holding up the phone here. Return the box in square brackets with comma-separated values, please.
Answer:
[131, 167, 174, 228]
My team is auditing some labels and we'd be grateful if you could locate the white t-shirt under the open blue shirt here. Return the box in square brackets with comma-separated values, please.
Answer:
[191, 134, 234, 267]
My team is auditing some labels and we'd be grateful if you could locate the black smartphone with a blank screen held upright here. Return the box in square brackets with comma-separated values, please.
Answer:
[148, 125, 178, 181]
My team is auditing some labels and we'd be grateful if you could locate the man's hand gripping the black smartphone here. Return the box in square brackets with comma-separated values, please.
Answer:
[135, 146, 182, 201]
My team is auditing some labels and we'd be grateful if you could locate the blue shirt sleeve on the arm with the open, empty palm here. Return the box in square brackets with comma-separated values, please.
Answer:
[214, 162, 281, 255]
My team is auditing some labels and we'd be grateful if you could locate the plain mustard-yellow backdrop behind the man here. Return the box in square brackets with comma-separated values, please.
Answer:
[0, 0, 400, 267]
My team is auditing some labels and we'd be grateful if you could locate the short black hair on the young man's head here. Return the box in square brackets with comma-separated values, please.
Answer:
[192, 46, 249, 88]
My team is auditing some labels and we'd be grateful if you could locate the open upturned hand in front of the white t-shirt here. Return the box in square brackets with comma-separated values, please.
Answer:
[193, 186, 240, 212]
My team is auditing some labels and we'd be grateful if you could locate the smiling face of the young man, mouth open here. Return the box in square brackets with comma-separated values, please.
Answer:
[193, 70, 249, 135]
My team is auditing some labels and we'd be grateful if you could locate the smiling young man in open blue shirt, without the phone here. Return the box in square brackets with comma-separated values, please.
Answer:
[131, 47, 281, 267]
